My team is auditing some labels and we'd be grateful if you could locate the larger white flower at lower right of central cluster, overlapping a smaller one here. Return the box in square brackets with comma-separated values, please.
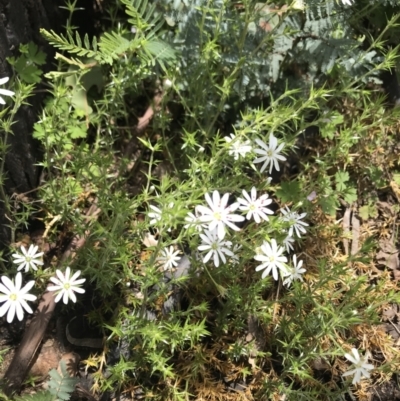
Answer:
[254, 239, 287, 280]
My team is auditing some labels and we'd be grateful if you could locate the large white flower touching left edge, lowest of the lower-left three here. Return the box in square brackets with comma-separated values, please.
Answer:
[0, 272, 36, 323]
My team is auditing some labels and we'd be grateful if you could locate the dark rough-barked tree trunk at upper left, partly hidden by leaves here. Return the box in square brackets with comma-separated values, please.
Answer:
[0, 0, 62, 249]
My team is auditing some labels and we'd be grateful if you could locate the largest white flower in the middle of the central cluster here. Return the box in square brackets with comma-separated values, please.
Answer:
[197, 191, 245, 239]
